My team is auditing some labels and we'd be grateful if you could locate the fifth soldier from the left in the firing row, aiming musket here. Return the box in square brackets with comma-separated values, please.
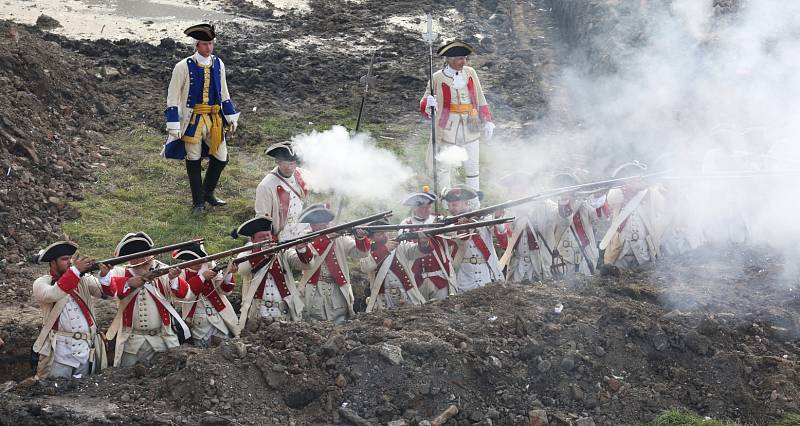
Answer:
[287, 204, 370, 324]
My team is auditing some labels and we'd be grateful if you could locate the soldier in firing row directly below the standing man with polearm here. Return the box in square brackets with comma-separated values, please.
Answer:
[442, 185, 506, 293]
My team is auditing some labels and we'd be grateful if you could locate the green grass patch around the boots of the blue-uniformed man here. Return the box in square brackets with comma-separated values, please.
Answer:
[64, 127, 271, 258]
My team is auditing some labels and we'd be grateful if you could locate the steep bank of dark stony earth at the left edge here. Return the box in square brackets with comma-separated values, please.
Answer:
[0, 22, 123, 300]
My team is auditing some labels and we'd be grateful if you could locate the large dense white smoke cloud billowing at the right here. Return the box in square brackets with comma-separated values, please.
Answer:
[482, 0, 800, 286]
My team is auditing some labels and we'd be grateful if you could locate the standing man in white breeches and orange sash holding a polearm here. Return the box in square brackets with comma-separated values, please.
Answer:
[420, 40, 494, 190]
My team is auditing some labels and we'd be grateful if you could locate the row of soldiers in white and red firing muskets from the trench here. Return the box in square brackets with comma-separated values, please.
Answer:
[33, 139, 676, 377]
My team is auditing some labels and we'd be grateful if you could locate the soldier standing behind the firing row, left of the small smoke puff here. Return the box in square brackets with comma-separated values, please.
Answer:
[255, 142, 308, 241]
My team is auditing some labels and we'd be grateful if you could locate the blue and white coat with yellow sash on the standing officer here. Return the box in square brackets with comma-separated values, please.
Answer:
[164, 53, 239, 160]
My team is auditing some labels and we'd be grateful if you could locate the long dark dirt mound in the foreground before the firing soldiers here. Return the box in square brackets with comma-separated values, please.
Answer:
[0, 249, 800, 425]
